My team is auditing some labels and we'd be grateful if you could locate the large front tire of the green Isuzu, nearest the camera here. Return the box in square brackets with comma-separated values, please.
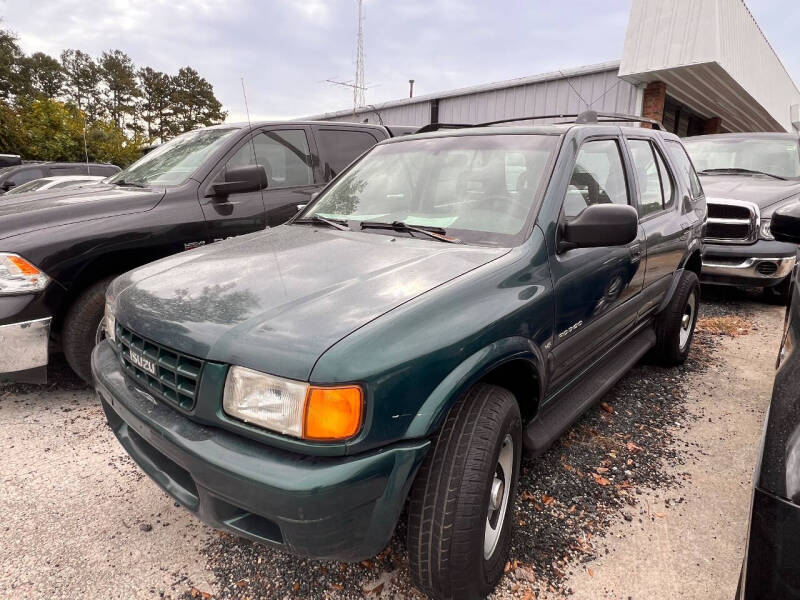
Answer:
[407, 384, 522, 600]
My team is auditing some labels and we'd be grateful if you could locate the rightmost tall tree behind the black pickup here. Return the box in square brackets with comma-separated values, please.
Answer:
[169, 67, 226, 135]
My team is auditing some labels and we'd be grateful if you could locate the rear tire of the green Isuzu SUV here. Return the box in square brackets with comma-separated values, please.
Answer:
[650, 271, 700, 366]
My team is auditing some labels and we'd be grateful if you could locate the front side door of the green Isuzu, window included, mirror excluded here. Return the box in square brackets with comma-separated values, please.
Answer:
[550, 136, 646, 385]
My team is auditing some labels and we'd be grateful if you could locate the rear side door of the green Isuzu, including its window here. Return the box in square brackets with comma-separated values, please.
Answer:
[626, 134, 688, 317]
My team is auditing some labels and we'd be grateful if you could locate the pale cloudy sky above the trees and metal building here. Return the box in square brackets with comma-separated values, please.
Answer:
[0, 0, 800, 121]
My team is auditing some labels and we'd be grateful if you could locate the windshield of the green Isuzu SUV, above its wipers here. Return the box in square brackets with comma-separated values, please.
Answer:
[299, 135, 559, 245]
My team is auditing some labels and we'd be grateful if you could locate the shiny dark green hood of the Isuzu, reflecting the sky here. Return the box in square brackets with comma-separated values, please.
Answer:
[110, 225, 509, 380]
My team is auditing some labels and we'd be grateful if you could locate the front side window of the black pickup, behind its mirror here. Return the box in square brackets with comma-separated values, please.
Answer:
[227, 129, 314, 190]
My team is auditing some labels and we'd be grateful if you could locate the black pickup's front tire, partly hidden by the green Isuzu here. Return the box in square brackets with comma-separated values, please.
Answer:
[61, 276, 115, 384]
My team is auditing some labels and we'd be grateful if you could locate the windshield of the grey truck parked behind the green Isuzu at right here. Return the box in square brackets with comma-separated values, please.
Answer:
[684, 137, 800, 177]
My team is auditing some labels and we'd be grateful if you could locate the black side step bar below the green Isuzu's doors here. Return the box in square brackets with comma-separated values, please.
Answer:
[522, 327, 656, 456]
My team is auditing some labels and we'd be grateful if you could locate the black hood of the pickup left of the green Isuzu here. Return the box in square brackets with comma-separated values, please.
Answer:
[0, 183, 164, 239]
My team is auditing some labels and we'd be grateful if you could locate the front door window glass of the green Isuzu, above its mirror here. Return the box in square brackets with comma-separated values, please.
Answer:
[563, 140, 629, 218]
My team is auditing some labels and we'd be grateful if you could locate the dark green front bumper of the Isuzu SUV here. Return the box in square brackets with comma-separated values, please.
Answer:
[92, 342, 430, 561]
